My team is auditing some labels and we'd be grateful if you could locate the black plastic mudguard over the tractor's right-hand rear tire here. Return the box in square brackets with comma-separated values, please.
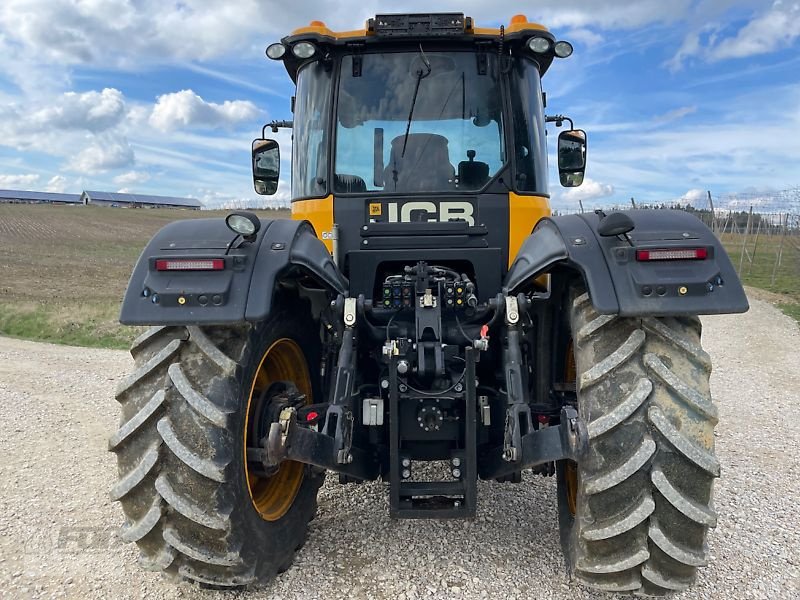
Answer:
[503, 210, 749, 317]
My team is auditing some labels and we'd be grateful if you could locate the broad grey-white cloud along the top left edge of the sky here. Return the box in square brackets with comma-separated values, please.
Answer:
[0, 0, 304, 67]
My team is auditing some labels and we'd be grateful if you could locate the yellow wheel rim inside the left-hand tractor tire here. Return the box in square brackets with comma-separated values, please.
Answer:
[243, 338, 312, 521]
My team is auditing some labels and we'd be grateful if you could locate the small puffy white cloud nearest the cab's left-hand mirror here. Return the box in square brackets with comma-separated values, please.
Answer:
[150, 90, 260, 131]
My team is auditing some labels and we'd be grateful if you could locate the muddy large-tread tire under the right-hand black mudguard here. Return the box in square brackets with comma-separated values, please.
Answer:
[558, 289, 720, 596]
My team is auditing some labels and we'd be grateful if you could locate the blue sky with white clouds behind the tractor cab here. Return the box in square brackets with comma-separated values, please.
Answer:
[0, 0, 800, 209]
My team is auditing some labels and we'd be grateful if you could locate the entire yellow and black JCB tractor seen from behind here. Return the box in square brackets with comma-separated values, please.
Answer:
[110, 14, 747, 595]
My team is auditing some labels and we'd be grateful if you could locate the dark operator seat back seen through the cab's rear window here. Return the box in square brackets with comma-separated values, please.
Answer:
[383, 133, 456, 192]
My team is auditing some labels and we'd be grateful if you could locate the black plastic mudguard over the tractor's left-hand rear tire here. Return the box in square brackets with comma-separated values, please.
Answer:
[119, 219, 347, 325]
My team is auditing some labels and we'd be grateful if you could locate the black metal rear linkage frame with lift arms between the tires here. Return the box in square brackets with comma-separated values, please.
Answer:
[261, 276, 588, 518]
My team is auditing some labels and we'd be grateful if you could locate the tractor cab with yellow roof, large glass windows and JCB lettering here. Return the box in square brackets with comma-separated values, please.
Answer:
[253, 13, 585, 288]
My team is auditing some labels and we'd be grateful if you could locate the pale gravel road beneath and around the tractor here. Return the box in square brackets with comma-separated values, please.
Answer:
[0, 300, 800, 600]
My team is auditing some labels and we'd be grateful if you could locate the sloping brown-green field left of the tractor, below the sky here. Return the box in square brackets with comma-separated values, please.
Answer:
[0, 204, 288, 348]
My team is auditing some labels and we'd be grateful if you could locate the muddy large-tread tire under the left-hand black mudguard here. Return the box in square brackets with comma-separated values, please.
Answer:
[109, 312, 324, 587]
